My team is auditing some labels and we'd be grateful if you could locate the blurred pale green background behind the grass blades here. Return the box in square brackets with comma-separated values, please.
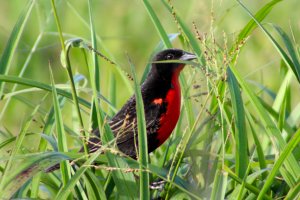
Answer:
[0, 0, 300, 132]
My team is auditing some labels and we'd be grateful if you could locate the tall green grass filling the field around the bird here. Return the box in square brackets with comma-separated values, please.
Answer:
[0, 0, 300, 199]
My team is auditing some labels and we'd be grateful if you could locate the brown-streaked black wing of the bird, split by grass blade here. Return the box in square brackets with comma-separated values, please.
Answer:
[89, 96, 166, 158]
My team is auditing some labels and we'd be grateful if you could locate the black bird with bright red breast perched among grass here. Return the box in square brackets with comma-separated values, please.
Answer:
[88, 49, 196, 159]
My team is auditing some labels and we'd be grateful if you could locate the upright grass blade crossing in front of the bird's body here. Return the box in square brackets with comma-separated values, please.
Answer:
[129, 55, 150, 199]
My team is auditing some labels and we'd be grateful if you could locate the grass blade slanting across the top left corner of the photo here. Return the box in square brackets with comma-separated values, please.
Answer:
[0, 0, 35, 99]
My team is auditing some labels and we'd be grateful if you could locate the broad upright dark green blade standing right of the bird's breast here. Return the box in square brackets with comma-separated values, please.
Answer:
[227, 68, 249, 178]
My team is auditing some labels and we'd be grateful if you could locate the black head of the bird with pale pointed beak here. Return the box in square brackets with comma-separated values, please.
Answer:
[152, 49, 197, 78]
